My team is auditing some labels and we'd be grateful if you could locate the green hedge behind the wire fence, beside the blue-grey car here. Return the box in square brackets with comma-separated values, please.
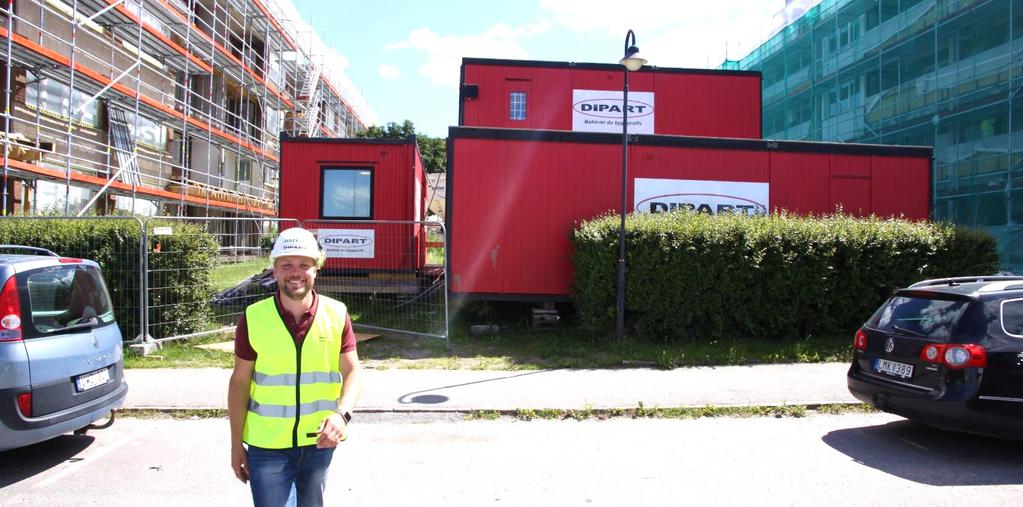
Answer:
[0, 217, 217, 339]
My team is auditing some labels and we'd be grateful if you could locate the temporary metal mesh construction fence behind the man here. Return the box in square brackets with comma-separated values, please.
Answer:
[0, 216, 448, 343]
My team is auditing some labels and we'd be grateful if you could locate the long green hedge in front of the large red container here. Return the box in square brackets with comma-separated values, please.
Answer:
[572, 212, 998, 341]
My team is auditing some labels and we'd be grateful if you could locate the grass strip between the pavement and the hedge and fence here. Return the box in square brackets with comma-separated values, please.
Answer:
[125, 307, 851, 370]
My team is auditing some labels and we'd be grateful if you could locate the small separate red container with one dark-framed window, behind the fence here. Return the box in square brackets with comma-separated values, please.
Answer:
[279, 133, 427, 272]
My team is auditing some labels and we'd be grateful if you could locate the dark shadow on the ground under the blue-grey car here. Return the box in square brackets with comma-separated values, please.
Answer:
[0, 434, 95, 489]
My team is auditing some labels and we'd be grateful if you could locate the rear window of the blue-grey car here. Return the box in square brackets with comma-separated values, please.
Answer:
[19, 266, 114, 337]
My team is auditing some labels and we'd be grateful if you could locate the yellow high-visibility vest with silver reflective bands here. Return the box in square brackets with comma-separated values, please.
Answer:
[241, 294, 348, 449]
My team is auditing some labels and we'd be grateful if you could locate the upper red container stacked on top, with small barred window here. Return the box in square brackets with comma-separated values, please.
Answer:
[458, 58, 761, 139]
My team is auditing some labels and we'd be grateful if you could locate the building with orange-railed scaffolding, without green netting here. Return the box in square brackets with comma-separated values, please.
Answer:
[0, 0, 365, 217]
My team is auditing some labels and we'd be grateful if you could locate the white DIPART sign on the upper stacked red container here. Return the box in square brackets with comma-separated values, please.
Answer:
[572, 90, 654, 134]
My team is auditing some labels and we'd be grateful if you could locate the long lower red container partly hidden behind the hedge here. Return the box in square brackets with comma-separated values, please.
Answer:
[446, 127, 932, 301]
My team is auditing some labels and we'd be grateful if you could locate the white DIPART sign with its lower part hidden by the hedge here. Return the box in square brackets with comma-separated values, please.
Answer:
[633, 178, 770, 217]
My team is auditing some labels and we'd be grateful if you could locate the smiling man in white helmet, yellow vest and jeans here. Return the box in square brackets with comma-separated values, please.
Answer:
[227, 228, 362, 506]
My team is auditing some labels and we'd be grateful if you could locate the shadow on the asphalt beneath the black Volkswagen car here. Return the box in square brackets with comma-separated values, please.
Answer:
[822, 420, 1023, 486]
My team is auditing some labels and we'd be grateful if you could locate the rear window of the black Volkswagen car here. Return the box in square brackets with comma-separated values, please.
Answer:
[869, 295, 969, 339]
